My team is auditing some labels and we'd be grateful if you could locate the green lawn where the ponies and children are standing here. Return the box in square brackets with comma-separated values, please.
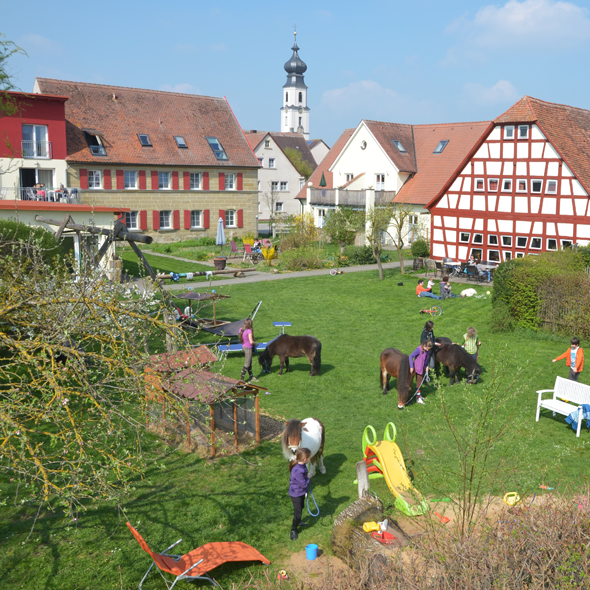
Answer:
[0, 268, 590, 590]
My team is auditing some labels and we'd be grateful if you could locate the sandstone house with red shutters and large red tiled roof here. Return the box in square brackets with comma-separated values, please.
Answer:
[34, 78, 259, 241]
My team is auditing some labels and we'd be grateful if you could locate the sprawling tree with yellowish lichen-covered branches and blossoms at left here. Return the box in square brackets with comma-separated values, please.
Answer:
[0, 229, 187, 511]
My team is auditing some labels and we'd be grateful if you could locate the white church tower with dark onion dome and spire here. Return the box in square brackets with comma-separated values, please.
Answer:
[281, 32, 309, 139]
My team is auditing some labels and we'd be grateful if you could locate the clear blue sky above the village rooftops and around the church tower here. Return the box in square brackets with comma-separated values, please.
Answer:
[0, 0, 590, 145]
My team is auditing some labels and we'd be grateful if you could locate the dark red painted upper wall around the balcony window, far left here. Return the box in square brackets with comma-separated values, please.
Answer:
[0, 92, 67, 160]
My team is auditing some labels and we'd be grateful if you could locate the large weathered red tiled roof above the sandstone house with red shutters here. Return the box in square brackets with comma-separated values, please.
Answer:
[37, 78, 259, 168]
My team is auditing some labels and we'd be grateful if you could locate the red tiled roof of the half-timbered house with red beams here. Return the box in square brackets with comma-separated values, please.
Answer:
[494, 96, 590, 193]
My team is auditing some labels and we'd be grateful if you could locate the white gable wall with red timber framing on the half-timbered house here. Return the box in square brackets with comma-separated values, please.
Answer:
[427, 121, 590, 262]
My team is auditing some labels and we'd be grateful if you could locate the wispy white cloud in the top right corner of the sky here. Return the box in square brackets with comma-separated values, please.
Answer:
[445, 0, 590, 62]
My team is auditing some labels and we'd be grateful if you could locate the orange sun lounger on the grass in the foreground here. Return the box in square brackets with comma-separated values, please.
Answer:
[127, 523, 270, 590]
